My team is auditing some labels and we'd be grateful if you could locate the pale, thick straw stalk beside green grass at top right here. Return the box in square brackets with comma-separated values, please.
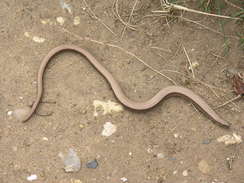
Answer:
[163, 0, 240, 20]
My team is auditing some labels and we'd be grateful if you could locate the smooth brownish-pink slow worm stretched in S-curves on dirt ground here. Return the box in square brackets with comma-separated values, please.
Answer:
[22, 45, 230, 127]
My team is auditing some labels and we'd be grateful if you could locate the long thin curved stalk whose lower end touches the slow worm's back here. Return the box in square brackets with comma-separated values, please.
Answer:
[61, 28, 177, 85]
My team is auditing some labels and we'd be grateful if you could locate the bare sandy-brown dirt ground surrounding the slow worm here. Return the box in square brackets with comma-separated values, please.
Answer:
[0, 0, 244, 183]
